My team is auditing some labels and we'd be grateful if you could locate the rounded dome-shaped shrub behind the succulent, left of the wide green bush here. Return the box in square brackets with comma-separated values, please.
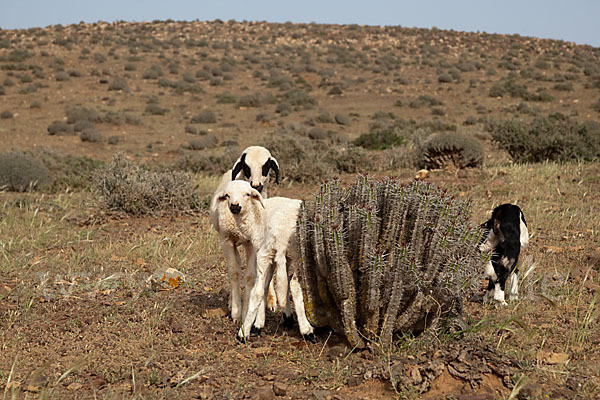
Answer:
[417, 133, 484, 169]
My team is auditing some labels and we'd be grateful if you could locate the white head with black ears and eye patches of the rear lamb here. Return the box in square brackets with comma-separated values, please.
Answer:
[231, 146, 279, 192]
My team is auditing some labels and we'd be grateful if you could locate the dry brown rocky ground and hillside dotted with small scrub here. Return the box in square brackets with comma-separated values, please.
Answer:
[0, 21, 600, 399]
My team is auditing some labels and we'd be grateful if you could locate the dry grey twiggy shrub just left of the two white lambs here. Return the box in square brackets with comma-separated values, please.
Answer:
[94, 155, 198, 215]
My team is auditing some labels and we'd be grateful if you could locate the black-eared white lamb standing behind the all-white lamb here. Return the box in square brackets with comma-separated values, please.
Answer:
[210, 146, 293, 333]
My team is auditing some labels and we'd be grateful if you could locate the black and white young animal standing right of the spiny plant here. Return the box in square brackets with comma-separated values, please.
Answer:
[479, 204, 529, 305]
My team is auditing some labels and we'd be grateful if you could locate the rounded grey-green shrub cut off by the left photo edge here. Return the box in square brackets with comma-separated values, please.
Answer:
[0, 151, 52, 192]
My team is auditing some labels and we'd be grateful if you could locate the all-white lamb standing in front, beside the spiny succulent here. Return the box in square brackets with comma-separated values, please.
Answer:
[217, 181, 315, 342]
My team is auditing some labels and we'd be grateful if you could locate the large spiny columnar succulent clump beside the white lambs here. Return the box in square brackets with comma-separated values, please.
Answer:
[297, 176, 489, 348]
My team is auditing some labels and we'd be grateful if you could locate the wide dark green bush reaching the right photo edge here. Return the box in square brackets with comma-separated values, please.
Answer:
[489, 114, 600, 162]
